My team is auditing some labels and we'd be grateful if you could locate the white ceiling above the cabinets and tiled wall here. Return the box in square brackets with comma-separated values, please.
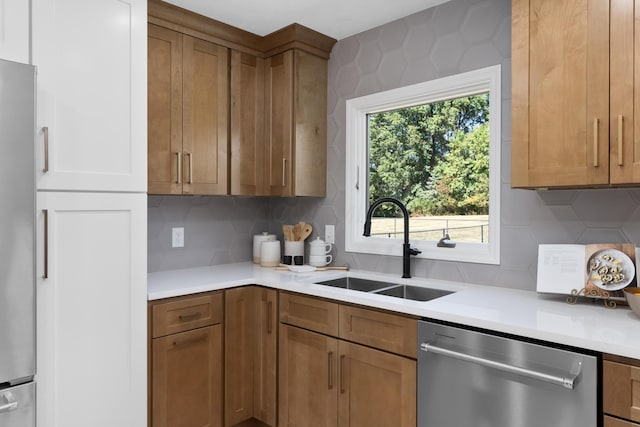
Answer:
[165, 0, 448, 40]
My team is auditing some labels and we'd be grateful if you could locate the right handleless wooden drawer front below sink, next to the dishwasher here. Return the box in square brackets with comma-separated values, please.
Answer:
[339, 305, 418, 359]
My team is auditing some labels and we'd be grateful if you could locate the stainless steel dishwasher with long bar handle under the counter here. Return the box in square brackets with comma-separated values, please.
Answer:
[418, 321, 602, 427]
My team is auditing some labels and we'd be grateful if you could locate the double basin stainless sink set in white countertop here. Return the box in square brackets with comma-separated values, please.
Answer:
[316, 277, 453, 301]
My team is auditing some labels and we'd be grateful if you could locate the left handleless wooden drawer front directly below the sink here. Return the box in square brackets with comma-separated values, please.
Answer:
[280, 292, 338, 336]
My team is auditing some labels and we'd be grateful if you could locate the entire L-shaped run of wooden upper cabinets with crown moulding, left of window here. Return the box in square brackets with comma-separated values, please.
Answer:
[148, 0, 336, 197]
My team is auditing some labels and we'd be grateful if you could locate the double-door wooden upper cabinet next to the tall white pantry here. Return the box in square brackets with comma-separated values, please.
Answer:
[147, 24, 229, 195]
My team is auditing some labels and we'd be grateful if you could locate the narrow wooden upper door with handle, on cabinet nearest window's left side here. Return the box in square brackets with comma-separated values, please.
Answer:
[265, 50, 293, 196]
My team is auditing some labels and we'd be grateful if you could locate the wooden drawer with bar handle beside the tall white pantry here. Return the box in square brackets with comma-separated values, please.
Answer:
[152, 292, 223, 338]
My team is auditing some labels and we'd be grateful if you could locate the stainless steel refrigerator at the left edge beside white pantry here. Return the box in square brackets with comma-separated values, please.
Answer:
[0, 60, 36, 427]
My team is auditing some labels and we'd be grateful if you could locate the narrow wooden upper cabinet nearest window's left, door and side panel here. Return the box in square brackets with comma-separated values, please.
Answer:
[265, 49, 327, 197]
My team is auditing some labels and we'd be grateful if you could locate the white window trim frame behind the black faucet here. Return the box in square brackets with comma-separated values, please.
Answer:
[345, 65, 502, 264]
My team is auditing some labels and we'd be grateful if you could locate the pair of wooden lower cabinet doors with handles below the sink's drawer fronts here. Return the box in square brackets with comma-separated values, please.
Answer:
[278, 324, 416, 427]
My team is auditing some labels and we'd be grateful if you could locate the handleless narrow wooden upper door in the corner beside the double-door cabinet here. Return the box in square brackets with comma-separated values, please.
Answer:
[231, 50, 265, 196]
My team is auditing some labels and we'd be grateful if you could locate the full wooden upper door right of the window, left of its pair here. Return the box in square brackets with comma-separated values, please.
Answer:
[511, 0, 609, 187]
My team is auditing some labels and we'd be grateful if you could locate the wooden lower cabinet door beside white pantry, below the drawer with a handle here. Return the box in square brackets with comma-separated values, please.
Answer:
[152, 325, 222, 427]
